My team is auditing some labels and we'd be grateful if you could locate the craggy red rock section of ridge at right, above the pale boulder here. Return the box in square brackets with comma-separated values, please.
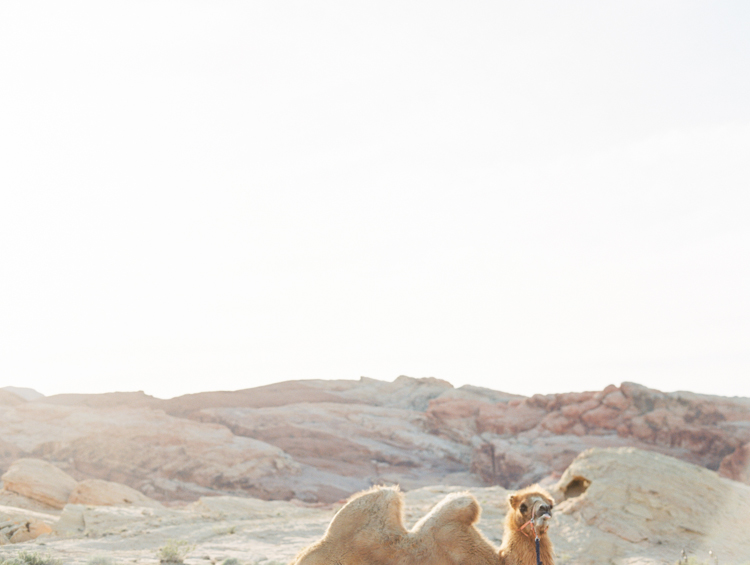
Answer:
[426, 383, 750, 488]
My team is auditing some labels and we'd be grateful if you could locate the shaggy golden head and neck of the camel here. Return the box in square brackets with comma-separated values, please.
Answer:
[500, 485, 554, 565]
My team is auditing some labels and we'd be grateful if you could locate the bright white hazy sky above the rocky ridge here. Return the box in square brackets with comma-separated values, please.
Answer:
[0, 0, 750, 397]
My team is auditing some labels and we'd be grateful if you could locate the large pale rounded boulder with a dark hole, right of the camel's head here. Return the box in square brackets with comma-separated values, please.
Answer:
[553, 448, 750, 565]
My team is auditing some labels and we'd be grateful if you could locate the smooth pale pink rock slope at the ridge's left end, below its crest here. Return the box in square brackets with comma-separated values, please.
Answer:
[0, 402, 299, 504]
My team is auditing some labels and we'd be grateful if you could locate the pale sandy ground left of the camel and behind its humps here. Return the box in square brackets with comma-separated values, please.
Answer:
[0, 486, 506, 565]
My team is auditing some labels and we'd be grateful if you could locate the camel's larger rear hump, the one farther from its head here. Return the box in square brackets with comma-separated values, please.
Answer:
[325, 487, 406, 540]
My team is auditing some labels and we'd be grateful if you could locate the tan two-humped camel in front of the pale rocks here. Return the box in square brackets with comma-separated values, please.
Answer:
[290, 487, 553, 565]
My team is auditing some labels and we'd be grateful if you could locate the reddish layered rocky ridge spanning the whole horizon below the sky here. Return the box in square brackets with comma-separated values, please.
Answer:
[0, 377, 750, 504]
